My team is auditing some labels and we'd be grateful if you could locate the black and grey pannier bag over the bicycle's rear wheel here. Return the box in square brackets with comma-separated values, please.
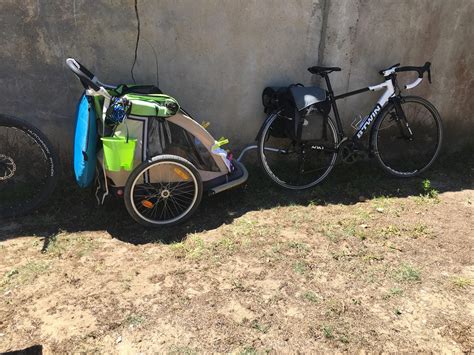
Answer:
[262, 84, 331, 141]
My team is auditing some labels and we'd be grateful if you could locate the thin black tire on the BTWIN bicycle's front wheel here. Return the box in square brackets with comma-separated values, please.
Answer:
[371, 96, 444, 178]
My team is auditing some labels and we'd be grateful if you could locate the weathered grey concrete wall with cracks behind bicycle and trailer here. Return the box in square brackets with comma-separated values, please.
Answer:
[0, 0, 474, 163]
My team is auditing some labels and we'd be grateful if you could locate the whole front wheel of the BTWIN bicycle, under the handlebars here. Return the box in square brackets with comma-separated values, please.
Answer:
[372, 96, 443, 177]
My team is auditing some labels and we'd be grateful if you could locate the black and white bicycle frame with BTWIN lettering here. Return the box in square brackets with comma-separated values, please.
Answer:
[324, 74, 395, 141]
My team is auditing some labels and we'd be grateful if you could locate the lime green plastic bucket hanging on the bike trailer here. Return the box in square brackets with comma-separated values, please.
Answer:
[101, 137, 137, 171]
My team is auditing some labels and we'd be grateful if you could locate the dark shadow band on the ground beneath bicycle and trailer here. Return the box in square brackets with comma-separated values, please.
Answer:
[0, 152, 474, 246]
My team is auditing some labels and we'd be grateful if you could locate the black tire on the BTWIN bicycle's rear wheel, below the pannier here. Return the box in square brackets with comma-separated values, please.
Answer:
[258, 114, 339, 190]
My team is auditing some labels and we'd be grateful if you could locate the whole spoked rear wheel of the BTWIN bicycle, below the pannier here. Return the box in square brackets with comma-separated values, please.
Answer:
[258, 114, 338, 190]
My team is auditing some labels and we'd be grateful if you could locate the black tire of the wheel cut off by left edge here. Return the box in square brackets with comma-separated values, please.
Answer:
[0, 114, 59, 219]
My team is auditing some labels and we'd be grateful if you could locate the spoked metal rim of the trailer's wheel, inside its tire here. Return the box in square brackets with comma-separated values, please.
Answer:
[130, 162, 199, 225]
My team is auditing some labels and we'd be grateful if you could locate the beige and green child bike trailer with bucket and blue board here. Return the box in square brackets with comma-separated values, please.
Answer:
[66, 58, 248, 227]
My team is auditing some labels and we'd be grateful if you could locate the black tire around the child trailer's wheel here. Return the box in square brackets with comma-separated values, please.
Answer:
[124, 155, 203, 227]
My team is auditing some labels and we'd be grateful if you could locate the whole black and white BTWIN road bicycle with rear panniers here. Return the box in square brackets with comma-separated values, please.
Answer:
[257, 62, 443, 190]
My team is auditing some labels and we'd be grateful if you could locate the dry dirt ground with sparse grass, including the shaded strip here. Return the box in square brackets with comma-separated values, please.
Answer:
[0, 155, 474, 354]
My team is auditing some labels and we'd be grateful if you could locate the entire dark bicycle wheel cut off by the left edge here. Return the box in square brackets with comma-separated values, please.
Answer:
[0, 115, 58, 218]
